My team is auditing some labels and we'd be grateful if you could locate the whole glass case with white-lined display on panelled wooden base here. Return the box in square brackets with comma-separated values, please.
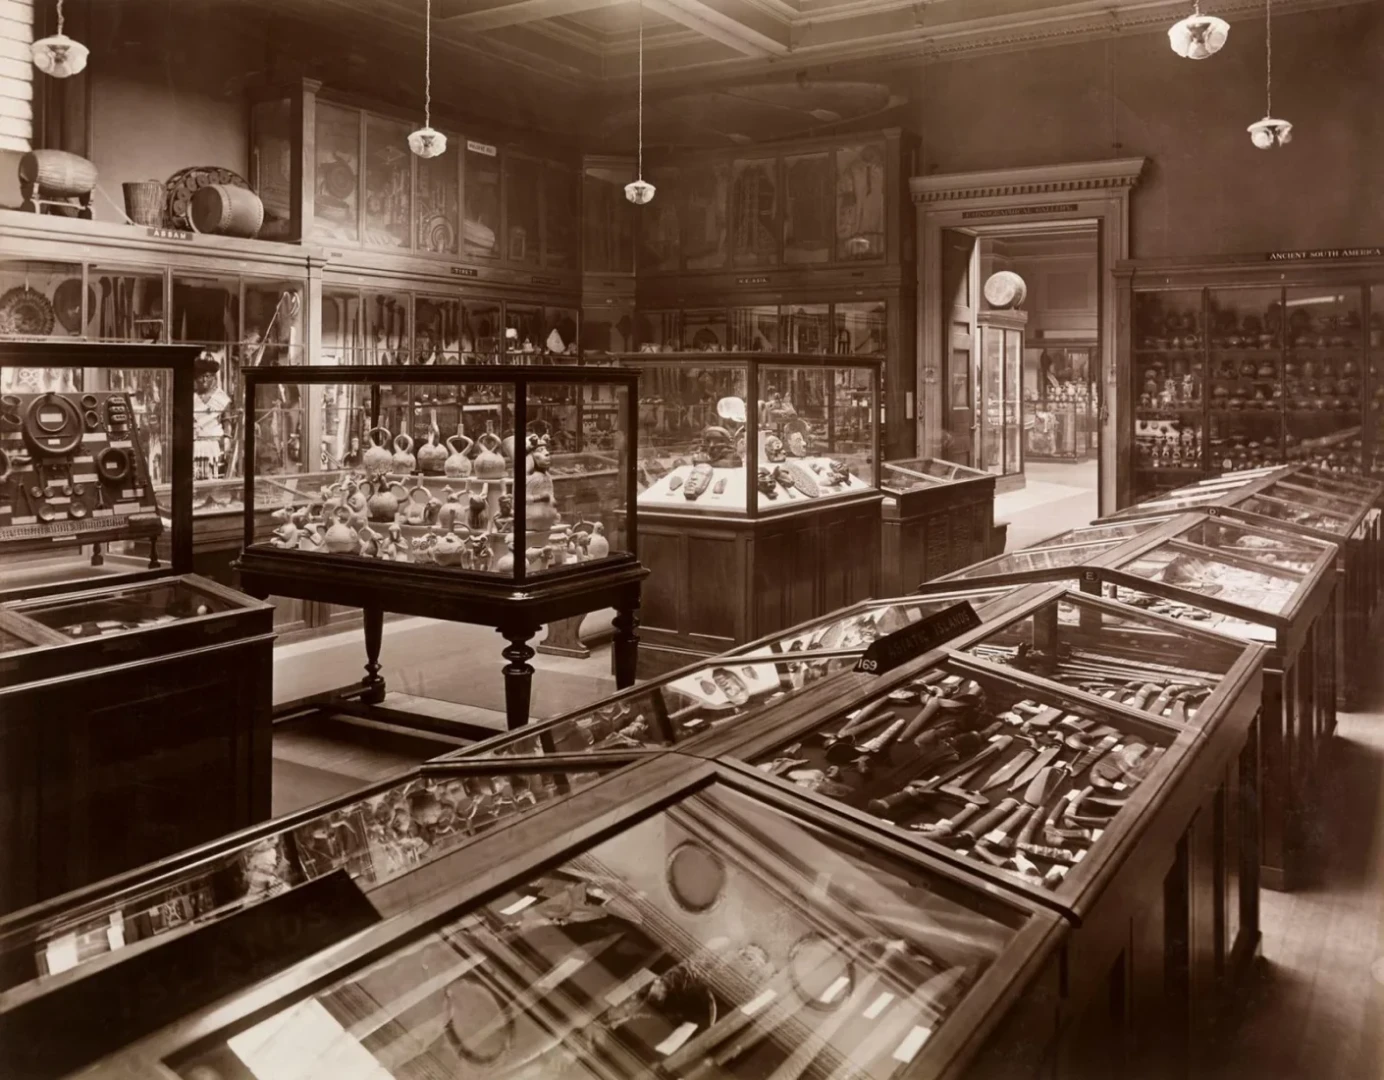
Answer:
[614, 353, 882, 676]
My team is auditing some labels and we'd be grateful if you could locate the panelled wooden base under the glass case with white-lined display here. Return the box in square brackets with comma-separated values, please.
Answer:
[638, 493, 882, 678]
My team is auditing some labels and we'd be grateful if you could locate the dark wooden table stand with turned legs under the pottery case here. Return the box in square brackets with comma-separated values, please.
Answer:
[235, 550, 649, 738]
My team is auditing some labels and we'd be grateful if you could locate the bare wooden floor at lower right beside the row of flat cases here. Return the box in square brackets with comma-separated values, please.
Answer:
[1211, 670, 1384, 1080]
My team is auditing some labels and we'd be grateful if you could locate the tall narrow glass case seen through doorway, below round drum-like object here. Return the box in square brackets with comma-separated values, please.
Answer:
[973, 312, 1028, 476]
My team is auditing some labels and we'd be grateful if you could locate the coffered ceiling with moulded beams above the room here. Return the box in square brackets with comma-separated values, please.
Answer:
[238, 0, 1381, 145]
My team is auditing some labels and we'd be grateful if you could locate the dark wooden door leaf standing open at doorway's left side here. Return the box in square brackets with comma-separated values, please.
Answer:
[938, 228, 978, 465]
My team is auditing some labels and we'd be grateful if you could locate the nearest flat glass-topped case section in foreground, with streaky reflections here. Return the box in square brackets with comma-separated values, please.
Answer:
[78, 759, 1064, 1080]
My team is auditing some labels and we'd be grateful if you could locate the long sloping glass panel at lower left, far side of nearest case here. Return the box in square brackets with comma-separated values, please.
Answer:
[0, 755, 630, 1014]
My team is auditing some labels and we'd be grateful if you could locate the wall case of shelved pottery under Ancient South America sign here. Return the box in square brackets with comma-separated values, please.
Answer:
[1116, 253, 1384, 505]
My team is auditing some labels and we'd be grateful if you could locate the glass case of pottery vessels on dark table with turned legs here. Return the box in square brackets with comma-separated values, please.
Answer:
[237, 366, 646, 731]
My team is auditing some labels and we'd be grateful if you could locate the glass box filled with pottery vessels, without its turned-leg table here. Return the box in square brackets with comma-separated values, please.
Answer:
[245, 366, 634, 580]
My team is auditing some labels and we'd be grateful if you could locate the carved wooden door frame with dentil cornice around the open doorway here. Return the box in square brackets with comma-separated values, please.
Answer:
[909, 158, 1147, 514]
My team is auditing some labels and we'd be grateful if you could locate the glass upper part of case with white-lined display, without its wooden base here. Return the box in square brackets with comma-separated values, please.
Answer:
[619, 346, 880, 518]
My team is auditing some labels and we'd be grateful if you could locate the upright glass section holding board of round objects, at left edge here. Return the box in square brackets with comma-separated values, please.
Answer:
[0, 342, 197, 600]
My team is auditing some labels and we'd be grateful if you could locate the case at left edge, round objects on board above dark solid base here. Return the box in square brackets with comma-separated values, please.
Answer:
[0, 342, 273, 910]
